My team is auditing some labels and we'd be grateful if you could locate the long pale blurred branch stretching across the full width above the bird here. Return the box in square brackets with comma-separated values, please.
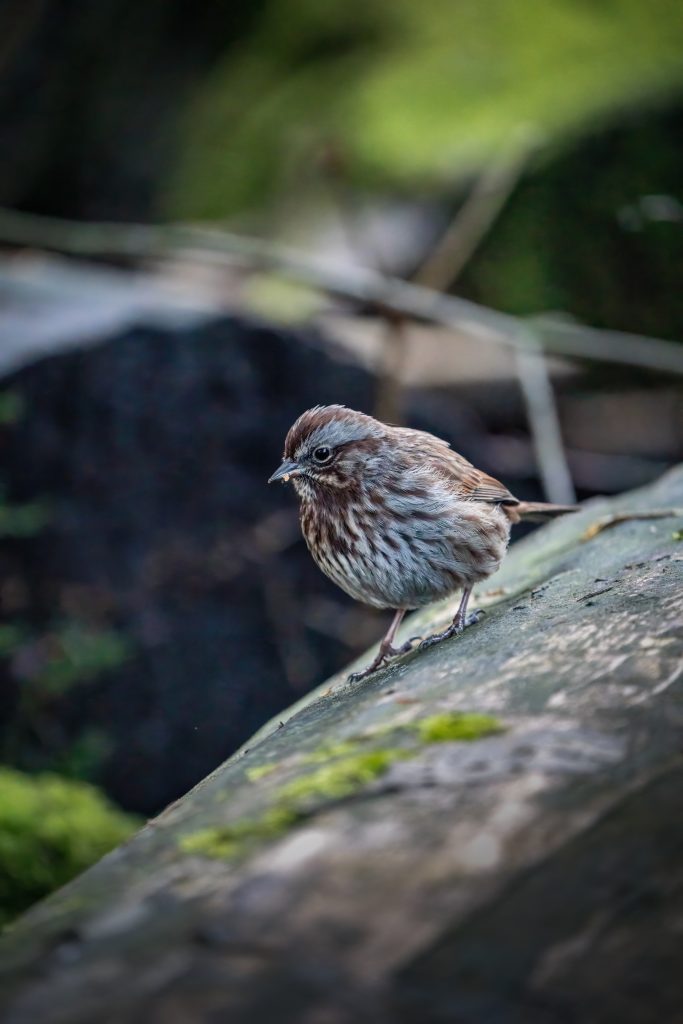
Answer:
[0, 203, 683, 375]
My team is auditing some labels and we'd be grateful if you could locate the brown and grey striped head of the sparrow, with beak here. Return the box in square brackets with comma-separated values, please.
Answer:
[268, 406, 388, 497]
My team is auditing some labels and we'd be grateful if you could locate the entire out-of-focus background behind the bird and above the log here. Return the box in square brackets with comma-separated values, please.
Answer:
[0, 0, 683, 920]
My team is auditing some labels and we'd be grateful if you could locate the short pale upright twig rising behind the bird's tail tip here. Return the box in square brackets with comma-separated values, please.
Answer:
[515, 327, 577, 505]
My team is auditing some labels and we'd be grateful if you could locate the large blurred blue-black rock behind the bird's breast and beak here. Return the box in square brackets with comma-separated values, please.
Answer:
[3, 318, 379, 812]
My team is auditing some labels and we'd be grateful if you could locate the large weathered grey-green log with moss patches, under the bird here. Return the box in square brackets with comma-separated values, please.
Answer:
[0, 469, 683, 1024]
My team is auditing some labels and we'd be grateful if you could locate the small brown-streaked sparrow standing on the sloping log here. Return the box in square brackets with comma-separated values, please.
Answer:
[268, 404, 577, 681]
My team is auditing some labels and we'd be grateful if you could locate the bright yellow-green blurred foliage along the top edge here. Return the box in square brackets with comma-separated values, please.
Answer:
[169, 0, 683, 216]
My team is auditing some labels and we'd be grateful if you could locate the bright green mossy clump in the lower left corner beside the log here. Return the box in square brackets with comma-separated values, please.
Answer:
[0, 768, 137, 923]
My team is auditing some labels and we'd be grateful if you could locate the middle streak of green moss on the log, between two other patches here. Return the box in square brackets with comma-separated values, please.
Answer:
[280, 748, 415, 803]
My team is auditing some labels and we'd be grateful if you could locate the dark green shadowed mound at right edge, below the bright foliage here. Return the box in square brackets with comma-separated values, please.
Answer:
[460, 102, 683, 331]
